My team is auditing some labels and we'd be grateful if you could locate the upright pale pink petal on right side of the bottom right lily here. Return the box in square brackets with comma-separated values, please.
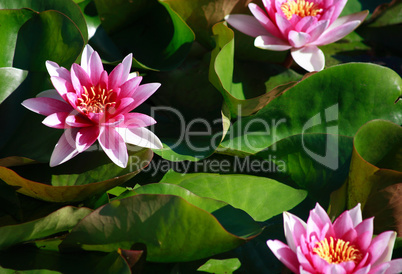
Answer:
[368, 231, 396, 267]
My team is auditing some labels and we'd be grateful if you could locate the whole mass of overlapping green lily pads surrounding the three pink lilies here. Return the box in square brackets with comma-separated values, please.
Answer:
[0, 0, 402, 273]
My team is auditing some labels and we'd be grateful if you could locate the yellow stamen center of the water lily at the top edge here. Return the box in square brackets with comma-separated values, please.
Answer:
[281, 0, 322, 20]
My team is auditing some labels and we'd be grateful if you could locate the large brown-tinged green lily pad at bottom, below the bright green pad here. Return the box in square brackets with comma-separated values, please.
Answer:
[60, 194, 260, 262]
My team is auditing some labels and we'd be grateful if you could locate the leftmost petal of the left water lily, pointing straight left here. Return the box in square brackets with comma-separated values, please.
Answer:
[22, 97, 73, 116]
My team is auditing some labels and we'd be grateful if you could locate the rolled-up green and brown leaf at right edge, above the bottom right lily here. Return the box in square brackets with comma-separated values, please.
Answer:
[347, 120, 402, 234]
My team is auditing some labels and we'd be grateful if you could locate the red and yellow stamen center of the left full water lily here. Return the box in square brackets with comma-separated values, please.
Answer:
[77, 87, 116, 114]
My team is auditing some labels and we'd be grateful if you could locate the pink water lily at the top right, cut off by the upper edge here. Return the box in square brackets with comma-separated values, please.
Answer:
[225, 0, 368, 71]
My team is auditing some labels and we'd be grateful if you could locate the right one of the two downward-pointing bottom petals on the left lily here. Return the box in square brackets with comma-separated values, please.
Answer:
[98, 127, 128, 168]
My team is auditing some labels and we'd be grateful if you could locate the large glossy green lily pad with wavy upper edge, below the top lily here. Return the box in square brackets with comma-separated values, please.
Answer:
[221, 63, 402, 155]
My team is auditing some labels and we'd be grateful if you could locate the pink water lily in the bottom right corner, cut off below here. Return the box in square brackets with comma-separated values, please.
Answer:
[267, 204, 402, 274]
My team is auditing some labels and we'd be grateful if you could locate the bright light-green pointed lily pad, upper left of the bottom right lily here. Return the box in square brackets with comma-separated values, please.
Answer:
[161, 172, 307, 221]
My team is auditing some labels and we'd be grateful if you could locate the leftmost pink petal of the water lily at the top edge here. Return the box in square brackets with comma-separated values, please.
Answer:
[225, 14, 267, 37]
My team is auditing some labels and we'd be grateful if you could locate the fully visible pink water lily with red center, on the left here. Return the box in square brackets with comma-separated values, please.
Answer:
[22, 45, 162, 167]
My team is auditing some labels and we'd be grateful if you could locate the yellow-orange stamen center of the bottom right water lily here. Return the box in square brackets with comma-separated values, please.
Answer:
[313, 237, 363, 264]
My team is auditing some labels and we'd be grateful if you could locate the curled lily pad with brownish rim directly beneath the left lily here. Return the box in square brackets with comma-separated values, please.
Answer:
[0, 149, 153, 202]
